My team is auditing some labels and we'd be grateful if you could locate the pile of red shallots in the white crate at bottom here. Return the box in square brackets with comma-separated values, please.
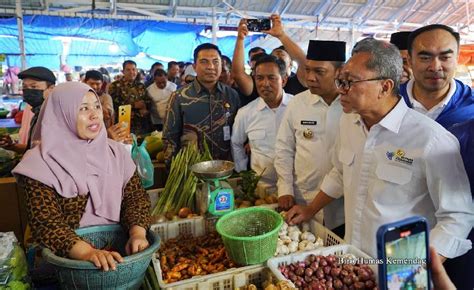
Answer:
[279, 255, 377, 289]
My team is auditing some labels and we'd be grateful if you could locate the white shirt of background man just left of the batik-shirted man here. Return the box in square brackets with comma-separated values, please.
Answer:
[146, 81, 177, 124]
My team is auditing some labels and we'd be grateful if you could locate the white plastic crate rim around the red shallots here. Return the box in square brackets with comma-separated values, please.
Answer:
[267, 244, 378, 286]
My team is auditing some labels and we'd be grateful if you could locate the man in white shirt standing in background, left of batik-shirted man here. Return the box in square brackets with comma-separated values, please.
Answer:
[146, 69, 177, 131]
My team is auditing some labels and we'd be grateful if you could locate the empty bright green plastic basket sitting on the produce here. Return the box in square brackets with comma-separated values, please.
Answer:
[216, 207, 283, 265]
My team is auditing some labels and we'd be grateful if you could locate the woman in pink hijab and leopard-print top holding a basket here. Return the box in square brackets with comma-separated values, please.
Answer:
[13, 82, 150, 271]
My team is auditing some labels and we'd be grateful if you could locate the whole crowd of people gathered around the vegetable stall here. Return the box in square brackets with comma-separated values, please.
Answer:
[0, 15, 474, 289]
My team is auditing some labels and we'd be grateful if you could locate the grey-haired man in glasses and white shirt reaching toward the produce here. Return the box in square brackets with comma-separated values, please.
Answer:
[288, 38, 474, 258]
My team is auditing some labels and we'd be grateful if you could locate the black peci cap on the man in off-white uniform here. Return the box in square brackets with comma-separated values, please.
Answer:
[306, 40, 346, 62]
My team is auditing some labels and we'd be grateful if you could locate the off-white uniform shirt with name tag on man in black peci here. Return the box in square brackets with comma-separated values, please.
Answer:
[275, 90, 344, 229]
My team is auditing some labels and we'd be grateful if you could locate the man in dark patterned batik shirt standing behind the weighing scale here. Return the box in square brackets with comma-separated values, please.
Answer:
[163, 43, 240, 165]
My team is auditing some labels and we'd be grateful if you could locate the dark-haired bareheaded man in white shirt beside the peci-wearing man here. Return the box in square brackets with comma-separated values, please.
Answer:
[231, 55, 292, 186]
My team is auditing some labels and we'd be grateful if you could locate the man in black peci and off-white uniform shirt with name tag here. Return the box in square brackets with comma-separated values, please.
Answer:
[275, 40, 346, 236]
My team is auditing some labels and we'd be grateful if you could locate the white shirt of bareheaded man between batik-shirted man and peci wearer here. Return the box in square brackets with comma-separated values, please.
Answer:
[231, 92, 293, 186]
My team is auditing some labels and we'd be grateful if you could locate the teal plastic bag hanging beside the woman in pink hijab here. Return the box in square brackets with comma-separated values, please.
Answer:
[131, 134, 155, 188]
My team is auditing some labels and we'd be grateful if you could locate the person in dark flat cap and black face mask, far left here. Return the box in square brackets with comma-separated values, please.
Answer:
[0, 66, 56, 154]
